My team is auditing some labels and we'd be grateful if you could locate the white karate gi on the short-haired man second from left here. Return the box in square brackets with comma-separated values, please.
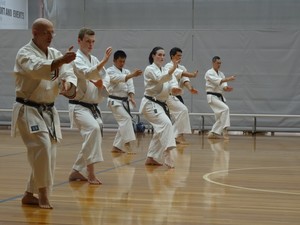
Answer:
[69, 49, 108, 176]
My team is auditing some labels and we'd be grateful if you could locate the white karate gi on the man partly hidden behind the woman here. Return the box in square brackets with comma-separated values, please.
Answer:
[165, 62, 192, 137]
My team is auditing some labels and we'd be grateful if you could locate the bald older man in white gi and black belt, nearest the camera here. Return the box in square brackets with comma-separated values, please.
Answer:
[12, 18, 77, 209]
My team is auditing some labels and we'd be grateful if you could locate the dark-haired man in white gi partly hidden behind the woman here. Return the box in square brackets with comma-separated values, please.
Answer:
[165, 47, 198, 144]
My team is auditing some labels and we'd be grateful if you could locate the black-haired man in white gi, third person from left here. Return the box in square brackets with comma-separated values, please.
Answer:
[107, 50, 143, 153]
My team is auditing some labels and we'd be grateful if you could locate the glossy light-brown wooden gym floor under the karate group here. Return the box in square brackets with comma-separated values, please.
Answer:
[0, 129, 300, 225]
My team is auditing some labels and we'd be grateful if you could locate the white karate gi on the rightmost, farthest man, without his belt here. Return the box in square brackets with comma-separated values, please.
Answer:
[204, 68, 230, 135]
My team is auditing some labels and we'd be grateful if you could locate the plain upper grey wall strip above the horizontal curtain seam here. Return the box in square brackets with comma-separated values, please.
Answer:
[28, 0, 300, 30]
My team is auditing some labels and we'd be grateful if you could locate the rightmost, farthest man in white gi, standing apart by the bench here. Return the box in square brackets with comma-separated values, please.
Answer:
[204, 56, 235, 139]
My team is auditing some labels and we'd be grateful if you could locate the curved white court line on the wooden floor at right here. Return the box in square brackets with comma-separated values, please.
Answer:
[203, 166, 300, 195]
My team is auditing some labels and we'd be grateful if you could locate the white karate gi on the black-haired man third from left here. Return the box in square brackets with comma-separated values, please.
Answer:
[107, 66, 136, 151]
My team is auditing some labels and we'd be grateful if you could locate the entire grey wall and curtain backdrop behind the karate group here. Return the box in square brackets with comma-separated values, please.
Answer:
[0, 0, 300, 127]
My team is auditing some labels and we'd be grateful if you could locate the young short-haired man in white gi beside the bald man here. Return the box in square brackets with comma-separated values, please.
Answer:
[69, 28, 112, 184]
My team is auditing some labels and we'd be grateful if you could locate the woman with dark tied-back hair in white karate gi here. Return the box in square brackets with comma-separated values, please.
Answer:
[140, 47, 182, 168]
